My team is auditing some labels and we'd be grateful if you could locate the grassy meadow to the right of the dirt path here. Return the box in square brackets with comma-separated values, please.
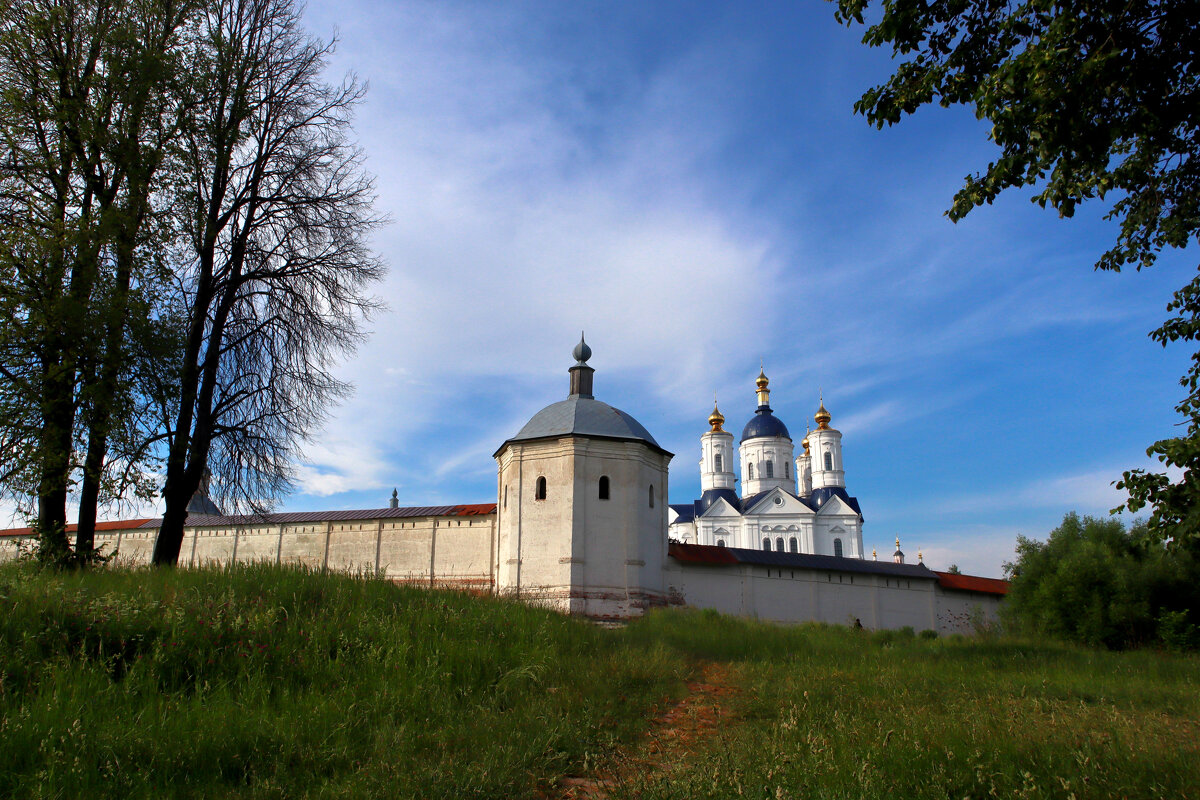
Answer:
[623, 613, 1200, 799]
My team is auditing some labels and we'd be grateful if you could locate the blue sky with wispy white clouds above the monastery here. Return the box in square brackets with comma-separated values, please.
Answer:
[9, 0, 1180, 575]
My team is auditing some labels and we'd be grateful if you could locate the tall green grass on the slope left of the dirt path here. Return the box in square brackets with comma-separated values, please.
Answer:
[0, 566, 684, 798]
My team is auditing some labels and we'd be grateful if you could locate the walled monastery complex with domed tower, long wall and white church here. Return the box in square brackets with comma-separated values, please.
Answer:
[0, 339, 1008, 633]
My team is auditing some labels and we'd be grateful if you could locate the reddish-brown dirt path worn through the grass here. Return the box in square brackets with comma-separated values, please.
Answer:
[545, 661, 738, 800]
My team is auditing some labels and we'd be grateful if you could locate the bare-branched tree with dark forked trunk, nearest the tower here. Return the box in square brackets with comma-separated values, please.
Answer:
[154, 0, 383, 565]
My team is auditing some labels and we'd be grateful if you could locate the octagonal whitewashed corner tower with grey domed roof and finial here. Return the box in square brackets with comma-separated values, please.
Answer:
[494, 337, 672, 619]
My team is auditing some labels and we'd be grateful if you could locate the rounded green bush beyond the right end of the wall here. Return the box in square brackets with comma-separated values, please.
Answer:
[1003, 513, 1200, 649]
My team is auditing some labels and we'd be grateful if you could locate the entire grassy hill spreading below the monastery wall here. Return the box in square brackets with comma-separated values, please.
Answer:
[0, 565, 1200, 798]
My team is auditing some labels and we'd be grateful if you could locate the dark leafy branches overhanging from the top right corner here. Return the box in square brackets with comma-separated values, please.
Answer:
[836, 0, 1200, 551]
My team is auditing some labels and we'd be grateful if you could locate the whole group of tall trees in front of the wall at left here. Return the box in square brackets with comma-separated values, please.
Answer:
[0, 0, 383, 564]
